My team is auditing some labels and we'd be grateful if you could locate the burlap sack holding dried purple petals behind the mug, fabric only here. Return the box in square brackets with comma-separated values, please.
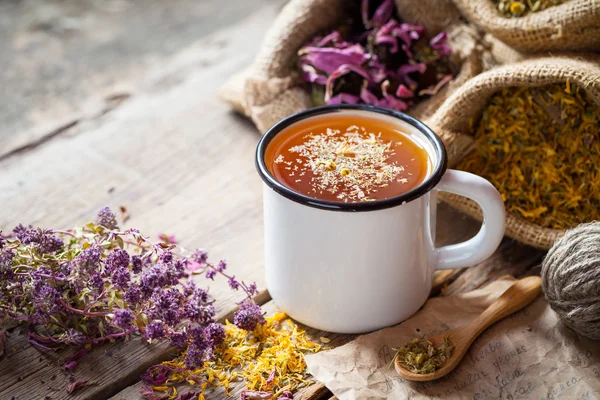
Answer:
[220, 0, 482, 132]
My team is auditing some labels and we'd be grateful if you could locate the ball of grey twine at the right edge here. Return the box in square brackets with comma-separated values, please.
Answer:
[542, 222, 600, 340]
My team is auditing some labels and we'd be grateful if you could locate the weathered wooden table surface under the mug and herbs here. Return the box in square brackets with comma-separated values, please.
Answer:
[0, 0, 542, 399]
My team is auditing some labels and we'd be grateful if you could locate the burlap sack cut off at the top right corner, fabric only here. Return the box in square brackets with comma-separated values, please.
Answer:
[453, 0, 600, 53]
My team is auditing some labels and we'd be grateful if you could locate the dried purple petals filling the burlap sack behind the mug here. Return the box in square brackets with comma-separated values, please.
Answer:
[298, 0, 452, 111]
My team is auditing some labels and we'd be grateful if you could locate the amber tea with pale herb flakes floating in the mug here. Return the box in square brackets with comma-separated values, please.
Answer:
[265, 113, 430, 203]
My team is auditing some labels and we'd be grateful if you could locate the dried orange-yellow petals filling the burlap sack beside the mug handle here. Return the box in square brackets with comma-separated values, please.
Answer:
[457, 81, 600, 229]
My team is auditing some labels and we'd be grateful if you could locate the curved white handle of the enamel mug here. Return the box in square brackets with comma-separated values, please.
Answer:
[436, 169, 505, 269]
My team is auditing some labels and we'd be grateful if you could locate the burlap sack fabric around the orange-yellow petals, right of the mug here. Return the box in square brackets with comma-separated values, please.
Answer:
[429, 55, 600, 249]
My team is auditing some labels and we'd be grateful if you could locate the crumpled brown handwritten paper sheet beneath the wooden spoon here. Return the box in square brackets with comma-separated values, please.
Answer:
[306, 278, 600, 400]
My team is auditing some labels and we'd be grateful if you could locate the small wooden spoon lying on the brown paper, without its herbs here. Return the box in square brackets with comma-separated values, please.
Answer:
[395, 276, 542, 382]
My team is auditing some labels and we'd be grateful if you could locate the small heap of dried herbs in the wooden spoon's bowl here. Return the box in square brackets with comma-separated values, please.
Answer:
[396, 338, 454, 374]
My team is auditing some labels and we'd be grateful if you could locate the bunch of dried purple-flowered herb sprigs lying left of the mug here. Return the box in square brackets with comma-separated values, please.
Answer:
[0, 208, 264, 366]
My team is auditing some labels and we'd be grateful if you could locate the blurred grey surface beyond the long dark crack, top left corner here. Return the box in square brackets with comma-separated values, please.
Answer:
[0, 0, 281, 159]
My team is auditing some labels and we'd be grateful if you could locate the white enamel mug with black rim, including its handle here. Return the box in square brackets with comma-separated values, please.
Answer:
[256, 105, 504, 333]
